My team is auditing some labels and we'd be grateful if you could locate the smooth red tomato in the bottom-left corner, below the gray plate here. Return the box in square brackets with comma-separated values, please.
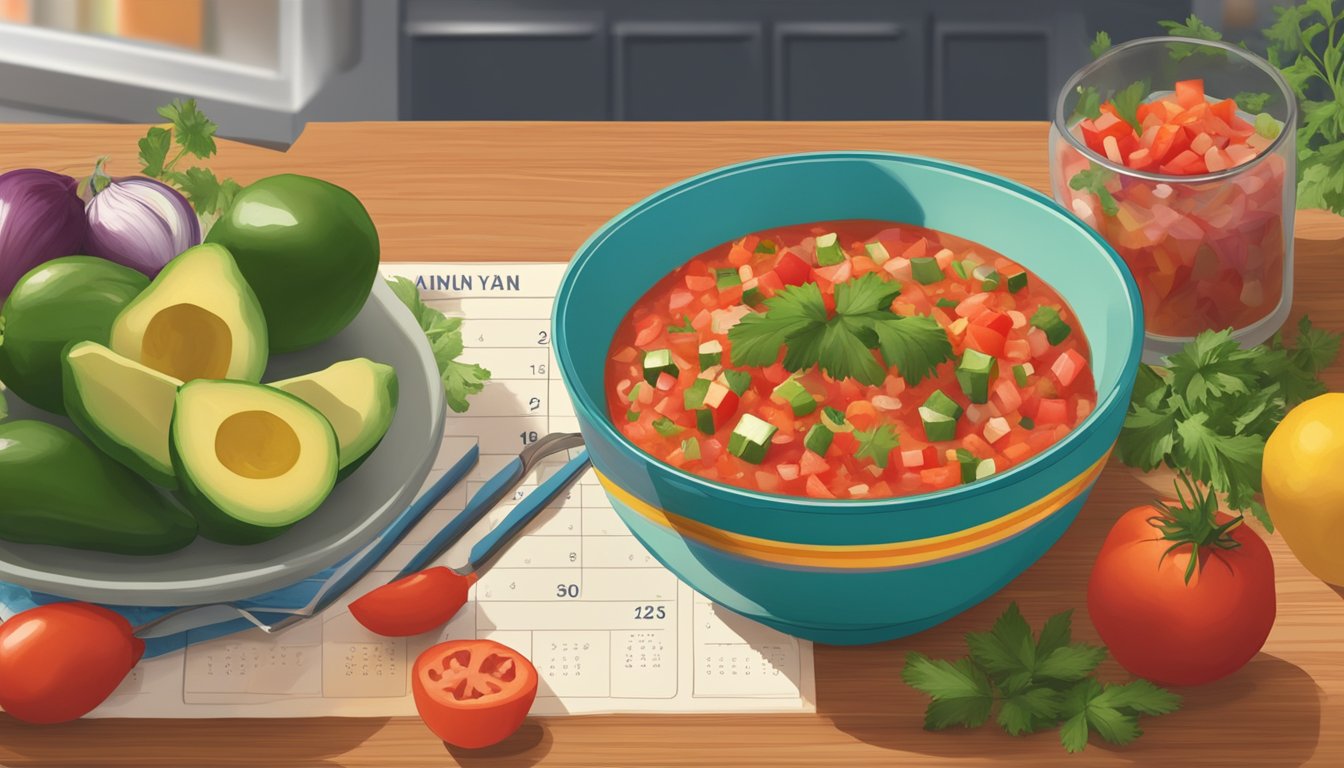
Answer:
[0, 603, 145, 724]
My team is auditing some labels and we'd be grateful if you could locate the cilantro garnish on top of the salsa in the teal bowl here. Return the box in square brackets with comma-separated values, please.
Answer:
[728, 273, 952, 385]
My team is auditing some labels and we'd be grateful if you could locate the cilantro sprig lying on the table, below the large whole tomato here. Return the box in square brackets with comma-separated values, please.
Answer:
[900, 603, 1180, 752]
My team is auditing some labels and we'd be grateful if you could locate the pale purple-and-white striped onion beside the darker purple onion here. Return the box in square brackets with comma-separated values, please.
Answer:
[85, 176, 200, 277]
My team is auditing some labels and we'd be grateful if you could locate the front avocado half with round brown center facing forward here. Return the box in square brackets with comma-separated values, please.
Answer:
[169, 379, 340, 545]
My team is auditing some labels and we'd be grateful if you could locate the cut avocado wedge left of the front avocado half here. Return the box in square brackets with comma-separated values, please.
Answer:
[62, 342, 181, 488]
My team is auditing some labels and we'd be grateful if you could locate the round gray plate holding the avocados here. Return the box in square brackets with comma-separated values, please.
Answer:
[0, 278, 444, 605]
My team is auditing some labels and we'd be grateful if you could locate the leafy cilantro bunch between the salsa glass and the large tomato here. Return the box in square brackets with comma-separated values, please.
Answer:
[1116, 317, 1340, 531]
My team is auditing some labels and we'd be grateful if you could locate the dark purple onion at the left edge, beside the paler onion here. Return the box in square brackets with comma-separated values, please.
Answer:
[0, 168, 87, 303]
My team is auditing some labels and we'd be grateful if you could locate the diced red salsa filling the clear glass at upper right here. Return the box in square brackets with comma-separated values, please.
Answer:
[1054, 79, 1293, 339]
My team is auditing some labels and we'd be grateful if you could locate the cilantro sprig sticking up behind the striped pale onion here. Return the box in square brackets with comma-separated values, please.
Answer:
[137, 98, 242, 217]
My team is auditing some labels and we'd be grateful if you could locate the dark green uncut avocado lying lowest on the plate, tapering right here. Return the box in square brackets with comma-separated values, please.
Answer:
[0, 420, 196, 555]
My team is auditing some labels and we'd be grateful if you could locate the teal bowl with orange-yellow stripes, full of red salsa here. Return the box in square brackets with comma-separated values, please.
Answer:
[554, 152, 1144, 644]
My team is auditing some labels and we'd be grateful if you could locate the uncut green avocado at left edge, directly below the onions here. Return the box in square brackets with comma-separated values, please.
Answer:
[0, 256, 149, 414]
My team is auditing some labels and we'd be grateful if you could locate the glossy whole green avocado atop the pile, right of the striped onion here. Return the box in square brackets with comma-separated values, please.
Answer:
[206, 174, 379, 352]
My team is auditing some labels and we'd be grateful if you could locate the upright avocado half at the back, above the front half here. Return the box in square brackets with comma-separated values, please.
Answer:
[108, 245, 269, 382]
